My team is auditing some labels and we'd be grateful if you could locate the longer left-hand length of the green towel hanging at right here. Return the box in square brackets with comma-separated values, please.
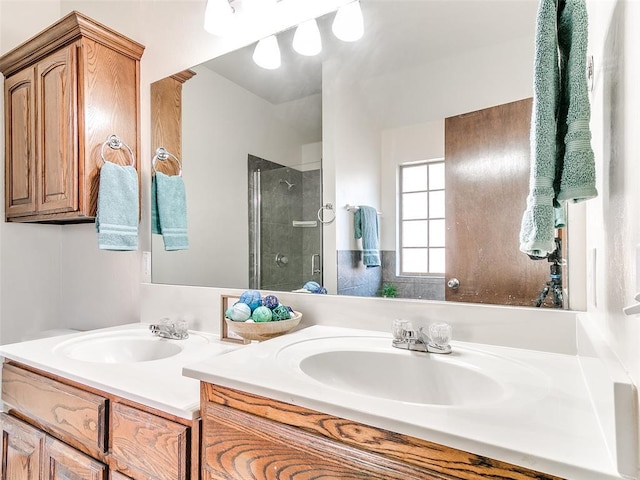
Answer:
[520, 0, 560, 257]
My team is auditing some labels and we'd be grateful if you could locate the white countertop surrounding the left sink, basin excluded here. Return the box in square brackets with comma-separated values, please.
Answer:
[0, 323, 237, 419]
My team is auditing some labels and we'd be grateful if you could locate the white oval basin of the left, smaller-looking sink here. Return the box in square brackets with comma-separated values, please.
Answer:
[54, 330, 206, 363]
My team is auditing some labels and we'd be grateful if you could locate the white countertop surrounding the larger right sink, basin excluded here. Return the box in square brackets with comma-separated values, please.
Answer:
[183, 326, 621, 480]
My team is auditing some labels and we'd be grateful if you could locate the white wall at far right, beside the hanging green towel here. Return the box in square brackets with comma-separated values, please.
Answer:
[587, 0, 640, 470]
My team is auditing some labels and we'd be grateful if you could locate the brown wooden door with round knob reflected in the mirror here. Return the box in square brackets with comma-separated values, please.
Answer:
[445, 99, 549, 306]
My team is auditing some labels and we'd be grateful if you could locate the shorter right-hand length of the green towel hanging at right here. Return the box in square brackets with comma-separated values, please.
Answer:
[556, 0, 598, 203]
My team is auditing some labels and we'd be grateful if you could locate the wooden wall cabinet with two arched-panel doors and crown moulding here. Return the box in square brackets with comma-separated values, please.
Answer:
[0, 12, 144, 223]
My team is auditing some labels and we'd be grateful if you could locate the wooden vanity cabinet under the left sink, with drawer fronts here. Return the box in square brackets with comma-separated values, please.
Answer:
[0, 362, 200, 480]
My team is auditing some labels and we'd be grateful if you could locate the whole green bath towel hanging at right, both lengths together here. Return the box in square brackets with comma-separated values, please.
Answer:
[520, 0, 597, 257]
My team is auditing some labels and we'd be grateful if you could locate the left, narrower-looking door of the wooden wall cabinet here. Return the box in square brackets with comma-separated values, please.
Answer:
[4, 68, 36, 218]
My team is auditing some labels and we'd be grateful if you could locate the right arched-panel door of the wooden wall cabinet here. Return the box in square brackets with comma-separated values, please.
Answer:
[36, 44, 78, 213]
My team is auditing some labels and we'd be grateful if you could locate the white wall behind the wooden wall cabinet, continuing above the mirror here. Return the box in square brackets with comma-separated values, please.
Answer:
[0, 0, 345, 343]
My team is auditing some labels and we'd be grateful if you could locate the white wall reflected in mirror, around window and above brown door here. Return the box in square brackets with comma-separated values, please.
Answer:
[322, 37, 533, 282]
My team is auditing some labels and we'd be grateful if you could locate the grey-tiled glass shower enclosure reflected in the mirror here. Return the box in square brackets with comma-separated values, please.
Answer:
[248, 155, 322, 291]
